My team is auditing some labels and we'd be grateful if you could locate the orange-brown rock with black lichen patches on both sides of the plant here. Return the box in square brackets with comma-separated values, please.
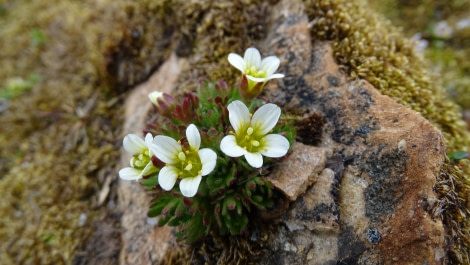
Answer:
[121, 1, 446, 264]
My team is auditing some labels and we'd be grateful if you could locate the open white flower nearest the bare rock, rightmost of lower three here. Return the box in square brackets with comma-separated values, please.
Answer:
[220, 100, 289, 168]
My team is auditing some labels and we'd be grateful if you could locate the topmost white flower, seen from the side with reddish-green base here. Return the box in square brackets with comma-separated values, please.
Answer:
[228, 48, 284, 98]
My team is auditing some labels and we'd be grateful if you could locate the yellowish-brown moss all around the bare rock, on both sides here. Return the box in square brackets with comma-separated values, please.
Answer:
[0, 0, 470, 264]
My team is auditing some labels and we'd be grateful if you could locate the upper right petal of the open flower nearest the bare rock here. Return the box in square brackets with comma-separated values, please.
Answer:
[251, 103, 281, 135]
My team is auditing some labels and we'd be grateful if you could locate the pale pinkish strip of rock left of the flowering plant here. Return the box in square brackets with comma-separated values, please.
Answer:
[118, 54, 185, 265]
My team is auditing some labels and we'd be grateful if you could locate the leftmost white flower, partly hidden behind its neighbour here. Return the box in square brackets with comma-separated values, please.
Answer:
[119, 133, 158, 180]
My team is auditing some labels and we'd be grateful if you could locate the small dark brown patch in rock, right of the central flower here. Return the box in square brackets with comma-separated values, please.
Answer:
[296, 113, 325, 145]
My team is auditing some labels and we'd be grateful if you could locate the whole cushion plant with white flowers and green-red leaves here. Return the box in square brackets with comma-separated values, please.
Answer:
[119, 48, 295, 242]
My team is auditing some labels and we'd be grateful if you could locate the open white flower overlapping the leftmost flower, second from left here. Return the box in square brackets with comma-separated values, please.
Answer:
[151, 124, 217, 197]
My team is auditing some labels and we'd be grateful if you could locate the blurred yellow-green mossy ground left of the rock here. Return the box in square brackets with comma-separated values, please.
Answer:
[0, 0, 158, 264]
